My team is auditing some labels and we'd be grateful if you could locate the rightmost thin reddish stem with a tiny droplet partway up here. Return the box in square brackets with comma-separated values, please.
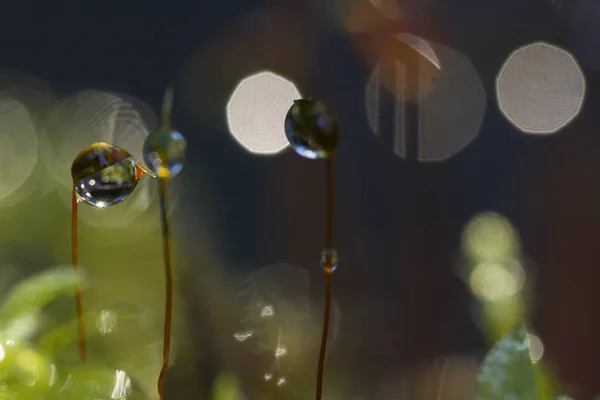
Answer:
[315, 157, 334, 400]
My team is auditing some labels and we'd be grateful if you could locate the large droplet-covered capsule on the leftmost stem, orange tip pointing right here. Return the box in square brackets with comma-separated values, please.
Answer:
[71, 143, 148, 207]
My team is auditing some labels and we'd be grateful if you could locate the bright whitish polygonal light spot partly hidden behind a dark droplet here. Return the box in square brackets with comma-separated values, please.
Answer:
[226, 71, 301, 155]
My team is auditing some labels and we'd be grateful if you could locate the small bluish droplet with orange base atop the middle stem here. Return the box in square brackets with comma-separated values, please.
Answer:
[144, 124, 187, 178]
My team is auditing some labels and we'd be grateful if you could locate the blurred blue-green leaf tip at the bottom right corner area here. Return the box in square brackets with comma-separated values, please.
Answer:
[475, 327, 538, 400]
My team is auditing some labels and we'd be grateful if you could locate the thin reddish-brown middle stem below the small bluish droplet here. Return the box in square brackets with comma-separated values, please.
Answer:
[158, 178, 173, 400]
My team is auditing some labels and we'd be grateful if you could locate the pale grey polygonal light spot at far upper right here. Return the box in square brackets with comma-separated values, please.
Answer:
[496, 42, 585, 135]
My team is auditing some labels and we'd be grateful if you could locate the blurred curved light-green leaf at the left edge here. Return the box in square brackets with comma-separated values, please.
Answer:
[0, 267, 80, 340]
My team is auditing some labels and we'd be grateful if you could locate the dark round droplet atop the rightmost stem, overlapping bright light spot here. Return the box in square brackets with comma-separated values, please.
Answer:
[285, 99, 338, 159]
